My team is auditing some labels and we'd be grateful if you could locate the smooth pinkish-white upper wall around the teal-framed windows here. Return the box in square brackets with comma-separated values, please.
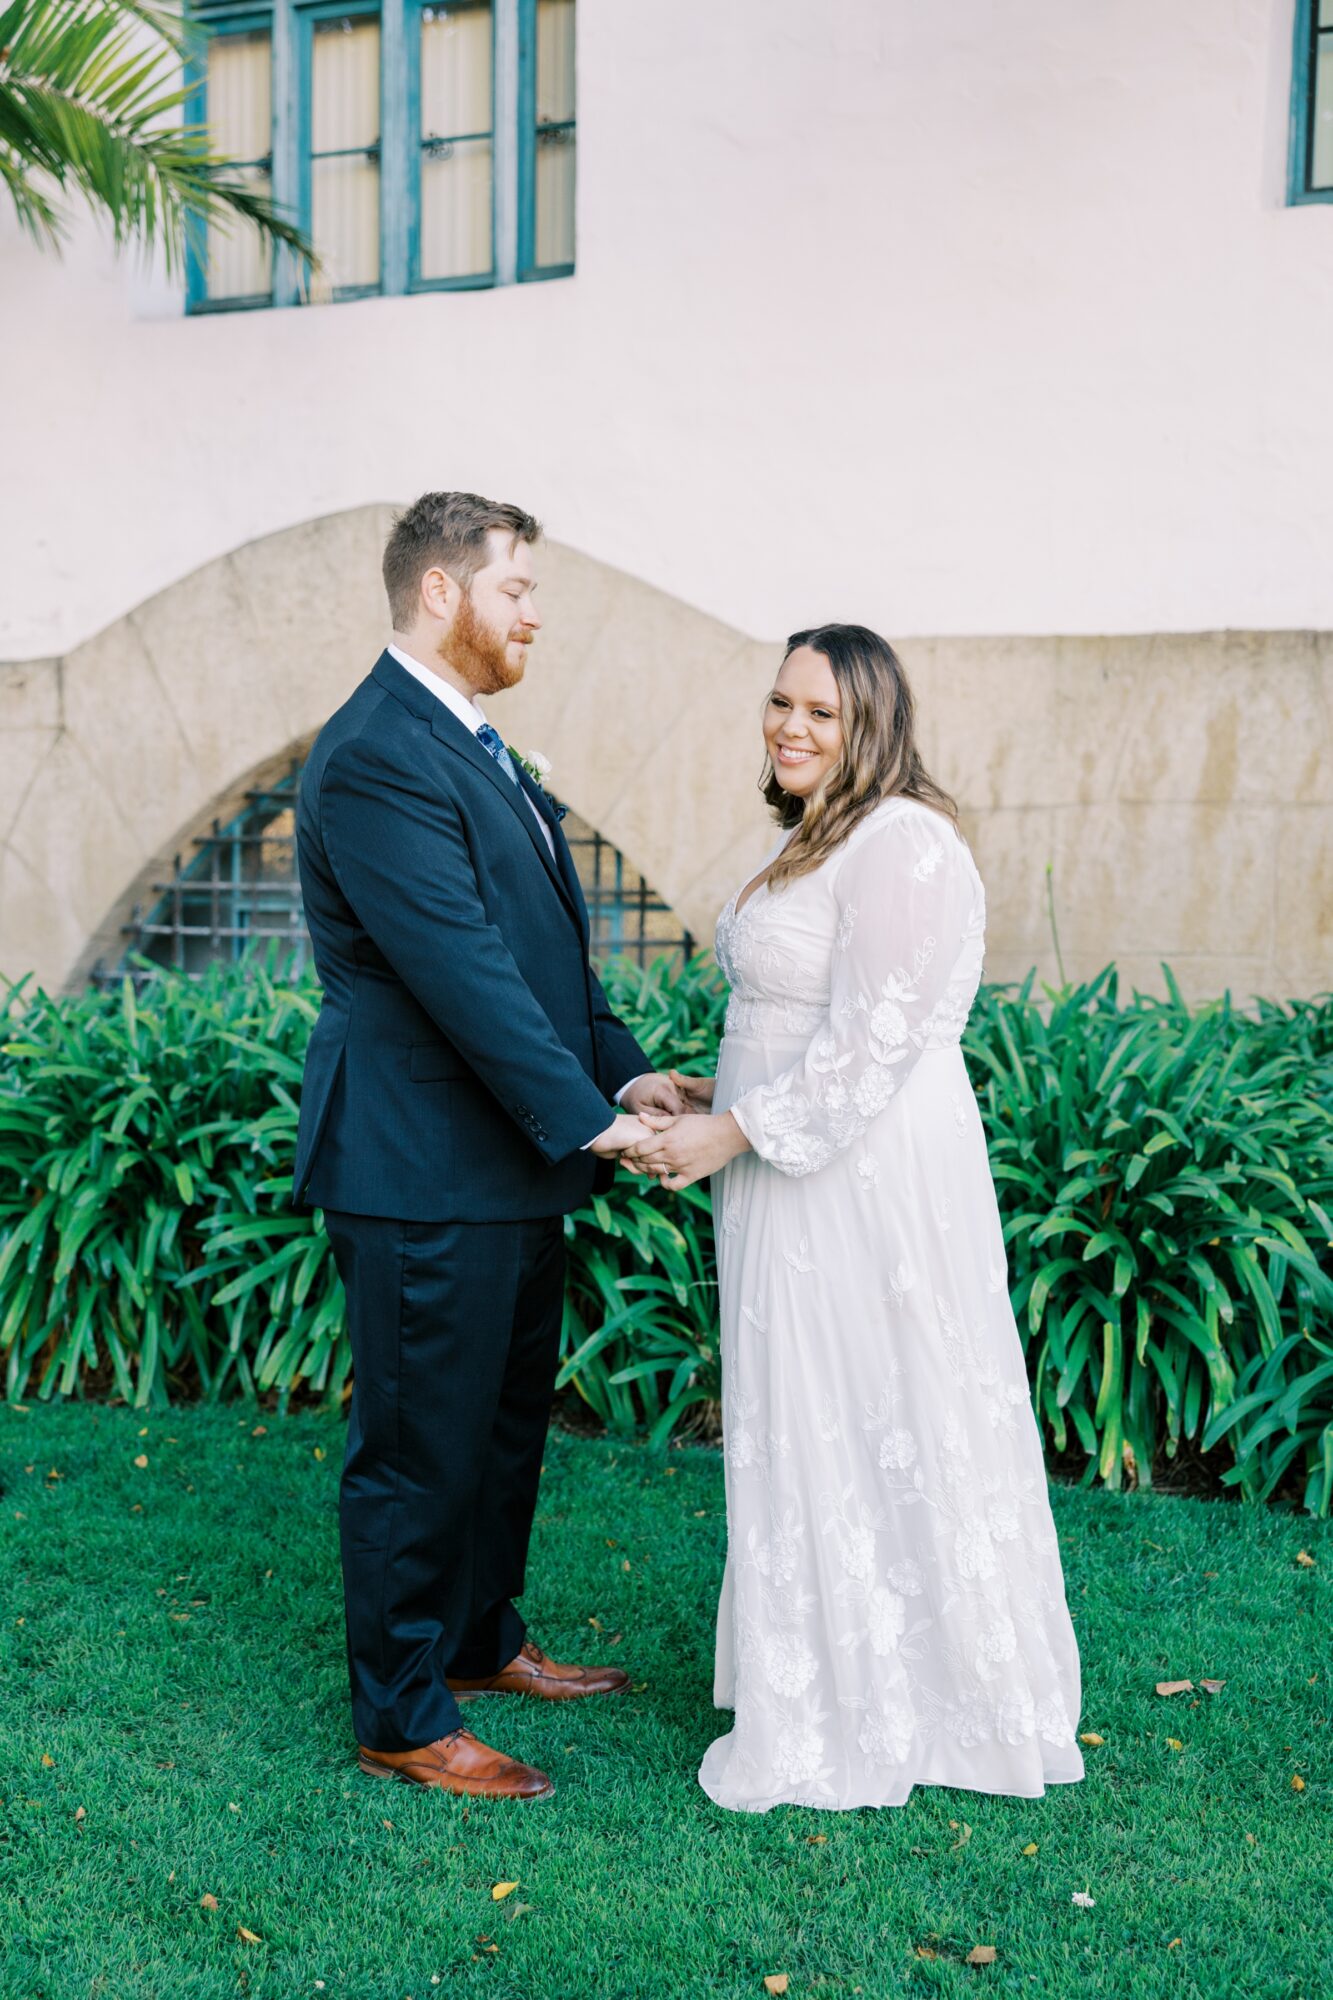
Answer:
[0, 0, 1333, 660]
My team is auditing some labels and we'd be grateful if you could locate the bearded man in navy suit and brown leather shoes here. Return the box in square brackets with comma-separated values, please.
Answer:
[294, 492, 683, 1798]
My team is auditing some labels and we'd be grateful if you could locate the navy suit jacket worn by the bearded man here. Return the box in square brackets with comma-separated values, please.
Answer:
[294, 654, 652, 1222]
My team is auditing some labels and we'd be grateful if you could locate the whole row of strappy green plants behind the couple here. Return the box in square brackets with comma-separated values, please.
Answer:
[0, 958, 1333, 1514]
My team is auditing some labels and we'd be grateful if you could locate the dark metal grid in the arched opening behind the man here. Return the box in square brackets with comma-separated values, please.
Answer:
[94, 764, 695, 984]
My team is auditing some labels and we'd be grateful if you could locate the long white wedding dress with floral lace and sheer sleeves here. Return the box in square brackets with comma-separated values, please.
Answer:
[699, 800, 1083, 1812]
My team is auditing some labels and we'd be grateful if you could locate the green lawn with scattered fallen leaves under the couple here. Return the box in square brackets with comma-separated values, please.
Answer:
[0, 1408, 1333, 2000]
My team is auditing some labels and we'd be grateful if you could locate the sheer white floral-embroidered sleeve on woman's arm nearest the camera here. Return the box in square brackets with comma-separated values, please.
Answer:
[731, 806, 985, 1174]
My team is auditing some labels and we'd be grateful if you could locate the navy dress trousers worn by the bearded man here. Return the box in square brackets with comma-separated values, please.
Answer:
[324, 1210, 564, 1750]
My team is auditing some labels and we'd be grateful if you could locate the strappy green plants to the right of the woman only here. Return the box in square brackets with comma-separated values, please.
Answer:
[965, 970, 1333, 1514]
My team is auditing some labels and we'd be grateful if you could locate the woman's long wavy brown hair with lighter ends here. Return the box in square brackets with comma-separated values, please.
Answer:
[759, 624, 959, 888]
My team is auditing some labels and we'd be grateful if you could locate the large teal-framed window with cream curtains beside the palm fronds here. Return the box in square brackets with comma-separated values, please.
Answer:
[188, 0, 576, 312]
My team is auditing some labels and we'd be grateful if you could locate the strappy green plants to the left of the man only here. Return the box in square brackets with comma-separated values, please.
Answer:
[0, 964, 338, 1406]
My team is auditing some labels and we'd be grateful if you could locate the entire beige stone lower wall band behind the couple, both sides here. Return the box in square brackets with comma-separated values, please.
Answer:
[0, 506, 1333, 996]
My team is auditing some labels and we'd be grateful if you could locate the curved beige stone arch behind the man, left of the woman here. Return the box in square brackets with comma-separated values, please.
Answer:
[0, 506, 775, 986]
